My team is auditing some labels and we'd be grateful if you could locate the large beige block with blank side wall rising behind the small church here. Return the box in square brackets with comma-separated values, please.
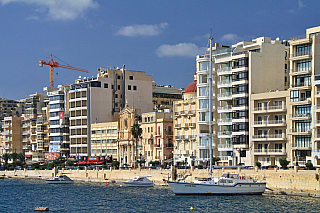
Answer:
[69, 67, 152, 157]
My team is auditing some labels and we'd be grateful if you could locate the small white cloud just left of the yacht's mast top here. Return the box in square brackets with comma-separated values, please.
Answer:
[156, 43, 206, 57]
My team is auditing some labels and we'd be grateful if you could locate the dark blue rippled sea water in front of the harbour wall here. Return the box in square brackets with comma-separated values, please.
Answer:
[0, 179, 320, 213]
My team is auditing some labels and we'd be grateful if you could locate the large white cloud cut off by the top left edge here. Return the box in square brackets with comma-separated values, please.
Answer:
[0, 0, 98, 20]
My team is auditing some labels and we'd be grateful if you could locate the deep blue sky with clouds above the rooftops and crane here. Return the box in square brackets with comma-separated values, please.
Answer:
[0, 0, 320, 100]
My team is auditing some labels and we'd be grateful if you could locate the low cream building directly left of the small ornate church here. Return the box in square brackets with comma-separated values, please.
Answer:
[91, 122, 118, 160]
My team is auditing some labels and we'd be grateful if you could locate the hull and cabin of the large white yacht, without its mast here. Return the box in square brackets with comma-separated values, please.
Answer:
[167, 173, 266, 195]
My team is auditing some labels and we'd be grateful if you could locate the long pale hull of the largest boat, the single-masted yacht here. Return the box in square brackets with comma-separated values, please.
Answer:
[167, 181, 266, 195]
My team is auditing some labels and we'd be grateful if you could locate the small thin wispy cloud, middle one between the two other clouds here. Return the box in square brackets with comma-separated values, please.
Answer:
[116, 22, 169, 37]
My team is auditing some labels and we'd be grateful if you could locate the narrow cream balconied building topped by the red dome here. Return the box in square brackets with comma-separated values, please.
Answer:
[173, 73, 198, 166]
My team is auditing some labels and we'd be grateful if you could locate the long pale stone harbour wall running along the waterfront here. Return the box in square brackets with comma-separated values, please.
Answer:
[0, 168, 320, 193]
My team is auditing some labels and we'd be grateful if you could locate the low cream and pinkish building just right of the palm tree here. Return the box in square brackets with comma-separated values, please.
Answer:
[138, 109, 173, 165]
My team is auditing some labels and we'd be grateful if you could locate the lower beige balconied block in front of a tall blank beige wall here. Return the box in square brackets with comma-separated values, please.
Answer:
[248, 90, 292, 166]
